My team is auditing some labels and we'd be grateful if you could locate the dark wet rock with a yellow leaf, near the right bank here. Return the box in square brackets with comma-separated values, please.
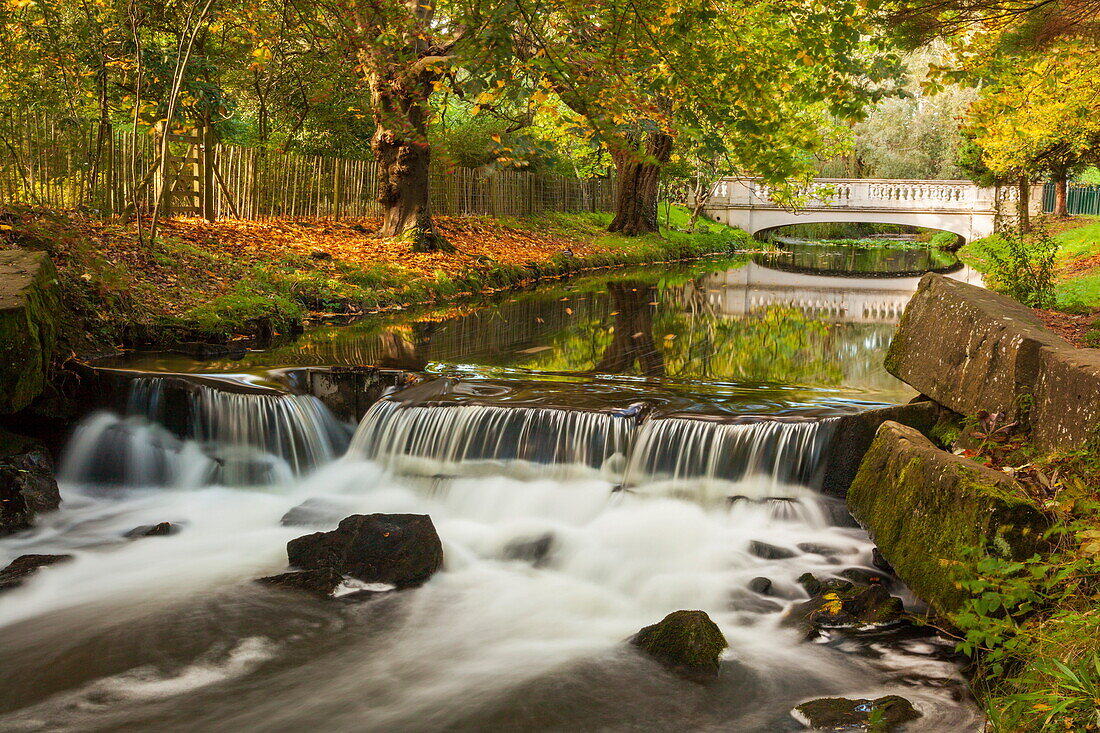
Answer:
[784, 572, 904, 633]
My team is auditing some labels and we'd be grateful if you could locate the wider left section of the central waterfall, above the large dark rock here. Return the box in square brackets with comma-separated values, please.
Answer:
[349, 400, 637, 481]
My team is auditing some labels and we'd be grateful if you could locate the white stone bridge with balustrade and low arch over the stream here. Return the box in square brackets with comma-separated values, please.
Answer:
[703, 178, 1043, 241]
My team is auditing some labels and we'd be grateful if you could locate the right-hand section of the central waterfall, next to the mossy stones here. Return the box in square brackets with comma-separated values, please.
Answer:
[623, 417, 835, 497]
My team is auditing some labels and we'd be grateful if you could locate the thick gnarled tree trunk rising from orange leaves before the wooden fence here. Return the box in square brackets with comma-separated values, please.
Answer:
[370, 59, 454, 252]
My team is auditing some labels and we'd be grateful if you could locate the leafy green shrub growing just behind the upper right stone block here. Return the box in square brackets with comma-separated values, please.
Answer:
[975, 227, 1058, 308]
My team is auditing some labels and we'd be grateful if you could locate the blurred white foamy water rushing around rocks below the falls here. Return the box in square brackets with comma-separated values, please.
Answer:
[0, 378, 974, 732]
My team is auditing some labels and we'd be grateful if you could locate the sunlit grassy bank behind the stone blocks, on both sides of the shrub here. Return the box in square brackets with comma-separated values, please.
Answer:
[959, 217, 1100, 347]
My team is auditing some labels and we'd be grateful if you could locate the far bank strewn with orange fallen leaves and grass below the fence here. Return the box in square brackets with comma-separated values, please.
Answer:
[0, 207, 754, 353]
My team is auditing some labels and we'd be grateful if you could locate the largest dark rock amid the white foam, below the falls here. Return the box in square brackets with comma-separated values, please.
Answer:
[286, 514, 443, 588]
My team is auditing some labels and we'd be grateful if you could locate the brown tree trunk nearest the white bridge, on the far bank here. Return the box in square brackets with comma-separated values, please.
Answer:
[607, 132, 672, 237]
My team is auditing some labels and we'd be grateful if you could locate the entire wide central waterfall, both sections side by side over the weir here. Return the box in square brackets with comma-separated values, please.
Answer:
[349, 391, 834, 497]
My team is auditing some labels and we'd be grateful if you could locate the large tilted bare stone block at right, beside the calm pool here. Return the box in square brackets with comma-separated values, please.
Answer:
[886, 274, 1073, 417]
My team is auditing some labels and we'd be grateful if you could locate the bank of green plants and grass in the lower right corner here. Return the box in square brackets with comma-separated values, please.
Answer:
[948, 420, 1100, 733]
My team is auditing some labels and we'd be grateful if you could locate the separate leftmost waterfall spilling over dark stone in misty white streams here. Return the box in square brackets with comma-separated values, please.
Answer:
[61, 378, 348, 488]
